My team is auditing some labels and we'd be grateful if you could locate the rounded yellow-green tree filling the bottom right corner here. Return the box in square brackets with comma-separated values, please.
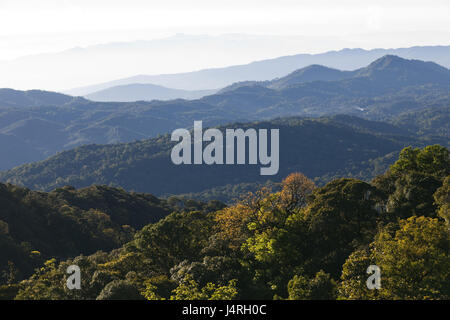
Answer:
[339, 217, 450, 300]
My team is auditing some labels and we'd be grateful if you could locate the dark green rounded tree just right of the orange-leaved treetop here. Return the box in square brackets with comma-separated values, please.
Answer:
[303, 178, 382, 278]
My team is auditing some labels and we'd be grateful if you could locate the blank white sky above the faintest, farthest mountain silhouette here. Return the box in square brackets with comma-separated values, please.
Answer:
[0, 0, 450, 90]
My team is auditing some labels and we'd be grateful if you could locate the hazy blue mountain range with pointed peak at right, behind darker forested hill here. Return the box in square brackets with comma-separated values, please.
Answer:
[0, 55, 450, 170]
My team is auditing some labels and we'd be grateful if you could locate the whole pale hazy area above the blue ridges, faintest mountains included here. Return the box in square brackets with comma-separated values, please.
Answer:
[0, 0, 450, 90]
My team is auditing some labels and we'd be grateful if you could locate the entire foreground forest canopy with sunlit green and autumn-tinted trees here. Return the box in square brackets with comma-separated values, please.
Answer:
[0, 145, 450, 300]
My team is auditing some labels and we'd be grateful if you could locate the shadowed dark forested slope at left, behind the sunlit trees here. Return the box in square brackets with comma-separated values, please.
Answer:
[0, 183, 222, 283]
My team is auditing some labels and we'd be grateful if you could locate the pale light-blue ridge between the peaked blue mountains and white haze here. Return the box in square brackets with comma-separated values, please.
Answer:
[64, 46, 450, 96]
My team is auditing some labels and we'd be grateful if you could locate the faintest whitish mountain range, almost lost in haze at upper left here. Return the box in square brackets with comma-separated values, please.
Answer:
[0, 33, 358, 91]
